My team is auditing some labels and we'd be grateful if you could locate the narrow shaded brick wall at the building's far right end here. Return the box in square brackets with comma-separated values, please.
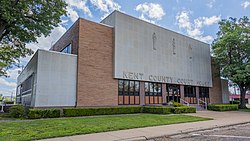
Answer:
[209, 59, 222, 103]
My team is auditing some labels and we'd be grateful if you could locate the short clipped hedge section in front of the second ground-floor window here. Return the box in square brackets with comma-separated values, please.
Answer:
[143, 106, 171, 114]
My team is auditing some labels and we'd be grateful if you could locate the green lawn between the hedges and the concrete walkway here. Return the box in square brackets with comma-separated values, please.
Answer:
[0, 114, 209, 141]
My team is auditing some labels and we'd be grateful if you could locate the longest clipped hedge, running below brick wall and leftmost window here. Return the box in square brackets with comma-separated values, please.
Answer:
[63, 106, 142, 117]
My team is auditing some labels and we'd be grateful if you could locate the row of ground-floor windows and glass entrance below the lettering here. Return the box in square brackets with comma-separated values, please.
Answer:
[118, 80, 209, 105]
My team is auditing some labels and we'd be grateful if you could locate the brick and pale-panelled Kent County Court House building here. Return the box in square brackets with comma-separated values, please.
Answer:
[17, 11, 229, 107]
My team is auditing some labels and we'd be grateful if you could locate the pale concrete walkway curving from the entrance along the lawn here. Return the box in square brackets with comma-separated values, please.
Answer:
[40, 111, 250, 141]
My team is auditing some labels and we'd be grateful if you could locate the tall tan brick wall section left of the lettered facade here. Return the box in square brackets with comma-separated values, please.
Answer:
[77, 19, 118, 107]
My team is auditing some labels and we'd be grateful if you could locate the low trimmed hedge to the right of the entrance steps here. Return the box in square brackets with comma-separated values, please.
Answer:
[207, 104, 238, 111]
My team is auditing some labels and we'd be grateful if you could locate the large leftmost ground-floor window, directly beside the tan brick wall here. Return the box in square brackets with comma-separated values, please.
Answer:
[118, 80, 140, 105]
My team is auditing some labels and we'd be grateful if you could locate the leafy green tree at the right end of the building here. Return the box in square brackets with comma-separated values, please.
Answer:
[212, 17, 250, 108]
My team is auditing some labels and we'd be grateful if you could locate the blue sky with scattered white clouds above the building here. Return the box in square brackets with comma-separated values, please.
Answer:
[0, 0, 250, 95]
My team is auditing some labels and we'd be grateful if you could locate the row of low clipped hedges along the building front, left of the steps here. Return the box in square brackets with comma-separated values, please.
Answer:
[23, 106, 196, 119]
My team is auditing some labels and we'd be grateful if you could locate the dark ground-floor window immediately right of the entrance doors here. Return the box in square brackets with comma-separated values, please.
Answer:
[184, 86, 197, 104]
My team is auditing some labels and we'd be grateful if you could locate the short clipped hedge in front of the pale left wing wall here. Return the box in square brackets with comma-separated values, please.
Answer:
[28, 109, 61, 119]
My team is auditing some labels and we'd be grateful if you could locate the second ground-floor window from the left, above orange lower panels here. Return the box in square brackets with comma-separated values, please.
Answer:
[144, 82, 162, 104]
